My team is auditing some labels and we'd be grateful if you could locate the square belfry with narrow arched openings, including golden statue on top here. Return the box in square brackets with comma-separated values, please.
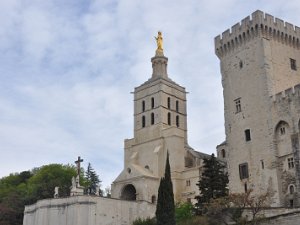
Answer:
[134, 32, 187, 143]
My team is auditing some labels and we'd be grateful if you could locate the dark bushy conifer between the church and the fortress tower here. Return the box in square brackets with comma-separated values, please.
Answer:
[196, 154, 228, 213]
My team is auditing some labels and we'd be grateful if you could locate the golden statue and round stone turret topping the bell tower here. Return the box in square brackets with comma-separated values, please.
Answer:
[151, 31, 168, 78]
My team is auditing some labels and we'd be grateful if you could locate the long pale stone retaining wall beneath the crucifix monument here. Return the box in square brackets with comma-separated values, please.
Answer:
[23, 196, 156, 225]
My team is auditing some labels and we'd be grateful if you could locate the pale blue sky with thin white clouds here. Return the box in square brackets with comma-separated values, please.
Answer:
[0, 0, 300, 188]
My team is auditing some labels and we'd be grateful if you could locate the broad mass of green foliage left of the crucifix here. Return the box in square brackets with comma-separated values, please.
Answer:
[0, 164, 76, 225]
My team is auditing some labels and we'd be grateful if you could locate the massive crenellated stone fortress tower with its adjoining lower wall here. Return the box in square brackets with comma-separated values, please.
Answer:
[215, 11, 300, 206]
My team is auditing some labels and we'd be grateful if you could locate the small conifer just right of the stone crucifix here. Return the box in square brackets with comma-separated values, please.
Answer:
[85, 163, 103, 196]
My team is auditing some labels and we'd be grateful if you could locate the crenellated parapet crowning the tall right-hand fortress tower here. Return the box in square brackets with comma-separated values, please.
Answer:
[215, 10, 300, 58]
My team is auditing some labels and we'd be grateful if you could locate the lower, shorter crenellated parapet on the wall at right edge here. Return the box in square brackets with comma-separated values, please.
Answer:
[270, 84, 300, 104]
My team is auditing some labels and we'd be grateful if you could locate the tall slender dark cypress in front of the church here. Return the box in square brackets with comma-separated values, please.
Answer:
[155, 153, 176, 225]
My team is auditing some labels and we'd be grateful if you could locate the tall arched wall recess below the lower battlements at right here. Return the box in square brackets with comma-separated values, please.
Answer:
[275, 120, 292, 156]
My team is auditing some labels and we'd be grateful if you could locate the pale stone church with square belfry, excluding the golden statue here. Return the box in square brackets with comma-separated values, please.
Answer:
[112, 33, 207, 203]
